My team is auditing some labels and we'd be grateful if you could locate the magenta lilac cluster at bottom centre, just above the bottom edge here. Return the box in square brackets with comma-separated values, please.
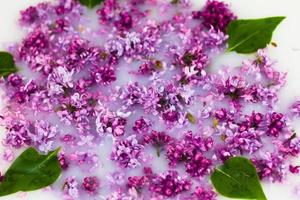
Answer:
[149, 171, 192, 197]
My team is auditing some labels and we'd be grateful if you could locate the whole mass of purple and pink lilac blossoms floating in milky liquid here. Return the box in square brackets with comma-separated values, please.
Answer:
[0, 0, 300, 200]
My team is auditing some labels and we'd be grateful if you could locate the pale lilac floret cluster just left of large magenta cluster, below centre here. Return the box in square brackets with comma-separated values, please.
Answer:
[111, 135, 144, 168]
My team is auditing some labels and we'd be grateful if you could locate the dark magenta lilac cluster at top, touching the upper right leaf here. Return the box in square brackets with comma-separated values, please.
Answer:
[200, 0, 236, 32]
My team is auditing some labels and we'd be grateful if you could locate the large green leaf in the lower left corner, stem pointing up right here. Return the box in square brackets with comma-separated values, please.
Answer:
[0, 147, 61, 196]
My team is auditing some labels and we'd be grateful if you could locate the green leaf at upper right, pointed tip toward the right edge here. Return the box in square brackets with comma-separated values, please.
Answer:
[227, 17, 285, 53]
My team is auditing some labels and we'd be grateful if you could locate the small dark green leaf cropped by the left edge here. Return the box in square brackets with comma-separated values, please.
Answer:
[0, 51, 18, 77]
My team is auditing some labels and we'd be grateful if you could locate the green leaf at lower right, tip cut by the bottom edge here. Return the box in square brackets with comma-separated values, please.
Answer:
[211, 157, 267, 200]
